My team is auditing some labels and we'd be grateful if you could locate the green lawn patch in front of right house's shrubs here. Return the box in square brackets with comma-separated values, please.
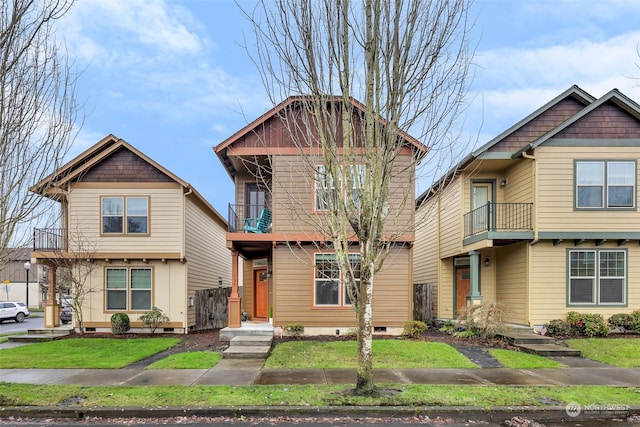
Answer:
[567, 338, 640, 368]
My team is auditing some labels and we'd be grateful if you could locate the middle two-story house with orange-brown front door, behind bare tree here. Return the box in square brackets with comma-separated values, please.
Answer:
[214, 97, 426, 335]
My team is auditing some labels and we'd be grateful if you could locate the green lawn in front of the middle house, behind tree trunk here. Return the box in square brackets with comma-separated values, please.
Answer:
[265, 340, 478, 368]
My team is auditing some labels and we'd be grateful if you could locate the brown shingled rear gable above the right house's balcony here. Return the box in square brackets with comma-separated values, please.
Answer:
[487, 98, 585, 152]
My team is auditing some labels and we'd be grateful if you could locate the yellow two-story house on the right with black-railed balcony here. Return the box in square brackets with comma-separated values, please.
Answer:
[413, 86, 640, 326]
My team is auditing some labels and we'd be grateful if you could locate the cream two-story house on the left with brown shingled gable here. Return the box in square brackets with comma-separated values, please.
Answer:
[31, 135, 231, 333]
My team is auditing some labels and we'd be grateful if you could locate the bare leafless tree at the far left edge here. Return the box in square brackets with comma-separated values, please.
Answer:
[0, 0, 80, 264]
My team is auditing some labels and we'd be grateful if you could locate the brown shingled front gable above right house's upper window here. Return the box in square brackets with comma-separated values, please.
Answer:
[555, 102, 640, 139]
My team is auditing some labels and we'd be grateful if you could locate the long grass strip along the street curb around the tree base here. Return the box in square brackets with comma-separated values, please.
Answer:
[0, 383, 640, 410]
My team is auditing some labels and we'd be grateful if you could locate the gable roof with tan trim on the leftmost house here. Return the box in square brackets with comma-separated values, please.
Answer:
[29, 134, 227, 227]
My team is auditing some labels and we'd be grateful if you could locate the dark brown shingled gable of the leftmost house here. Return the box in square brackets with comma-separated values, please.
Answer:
[77, 148, 173, 182]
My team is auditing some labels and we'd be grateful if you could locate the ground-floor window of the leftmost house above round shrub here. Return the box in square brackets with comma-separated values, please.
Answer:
[106, 267, 151, 311]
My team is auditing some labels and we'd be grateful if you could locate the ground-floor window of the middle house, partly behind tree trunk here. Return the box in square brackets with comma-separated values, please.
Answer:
[313, 253, 360, 307]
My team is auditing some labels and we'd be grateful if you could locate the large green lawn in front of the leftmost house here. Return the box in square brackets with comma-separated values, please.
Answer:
[0, 338, 180, 369]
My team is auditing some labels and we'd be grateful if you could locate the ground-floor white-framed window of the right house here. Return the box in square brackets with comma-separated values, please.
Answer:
[568, 250, 627, 305]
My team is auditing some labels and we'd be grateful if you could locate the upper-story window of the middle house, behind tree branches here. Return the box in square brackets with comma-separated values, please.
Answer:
[315, 165, 365, 211]
